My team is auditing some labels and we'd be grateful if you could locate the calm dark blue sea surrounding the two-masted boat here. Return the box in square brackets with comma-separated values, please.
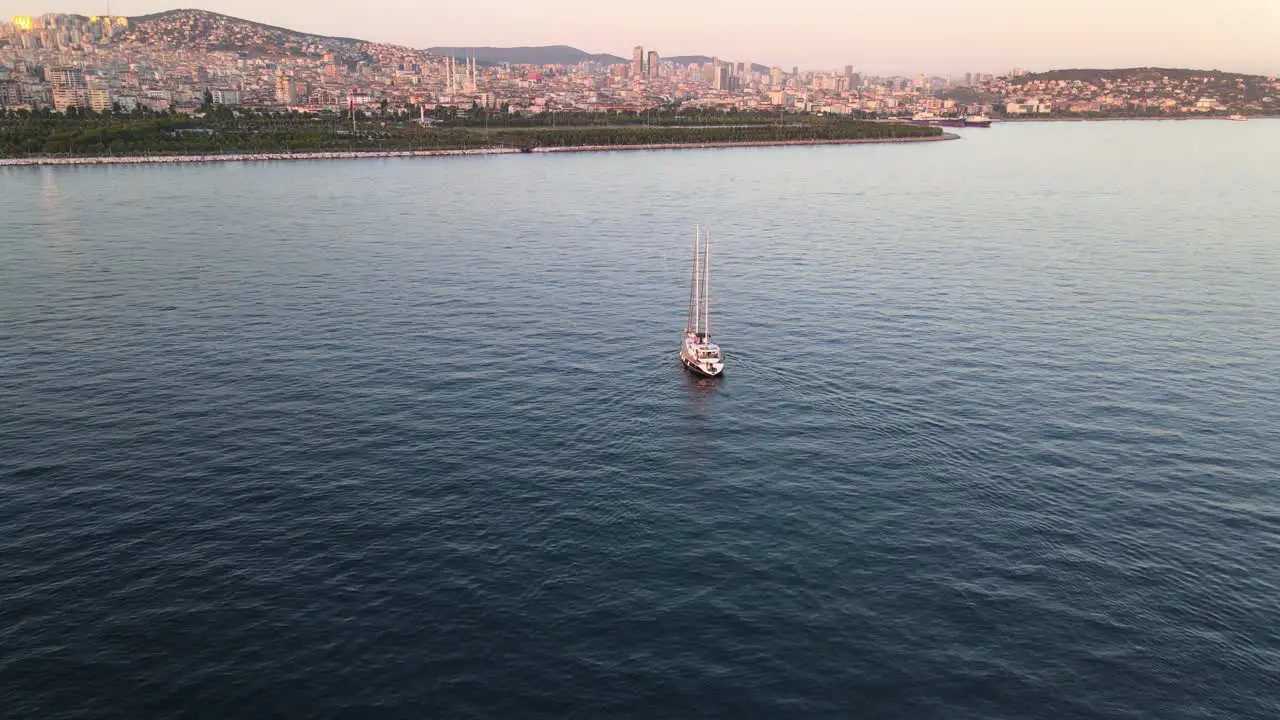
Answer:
[0, 120, 1280, 720]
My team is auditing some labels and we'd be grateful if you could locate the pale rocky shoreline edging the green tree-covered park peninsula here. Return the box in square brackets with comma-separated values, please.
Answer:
[0, 132, 960, 168]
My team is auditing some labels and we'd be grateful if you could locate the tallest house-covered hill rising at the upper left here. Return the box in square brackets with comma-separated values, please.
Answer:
[114, 9, 389, 61]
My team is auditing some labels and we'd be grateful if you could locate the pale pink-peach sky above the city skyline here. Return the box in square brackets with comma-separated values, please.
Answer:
[0, 0, 1280, 74]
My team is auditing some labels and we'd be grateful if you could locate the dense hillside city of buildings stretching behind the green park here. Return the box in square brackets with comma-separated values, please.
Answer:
[0, 10, 1280, 117]
